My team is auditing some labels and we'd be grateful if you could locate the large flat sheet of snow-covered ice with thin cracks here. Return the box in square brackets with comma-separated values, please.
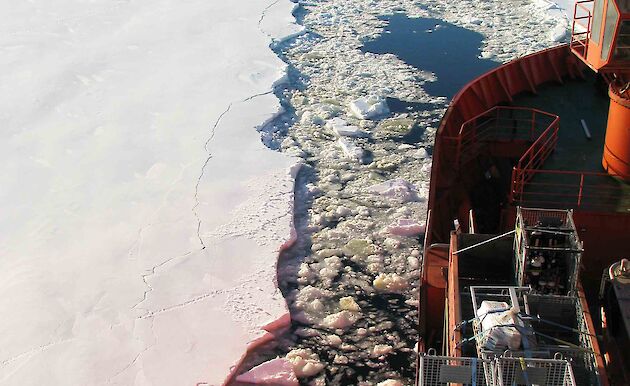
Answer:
[0, 0, 302, 385]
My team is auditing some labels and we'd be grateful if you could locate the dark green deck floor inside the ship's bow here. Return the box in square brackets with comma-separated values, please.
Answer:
[513, 73, 630, 213]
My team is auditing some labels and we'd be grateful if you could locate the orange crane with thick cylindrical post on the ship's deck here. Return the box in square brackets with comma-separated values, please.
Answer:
[570, 0, 630, 181]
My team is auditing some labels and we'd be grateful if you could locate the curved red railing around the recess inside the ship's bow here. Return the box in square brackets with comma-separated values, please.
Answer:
[447, 106, 560, 168]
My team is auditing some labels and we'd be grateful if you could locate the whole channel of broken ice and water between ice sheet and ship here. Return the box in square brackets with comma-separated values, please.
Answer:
[239, 0, 572, 386]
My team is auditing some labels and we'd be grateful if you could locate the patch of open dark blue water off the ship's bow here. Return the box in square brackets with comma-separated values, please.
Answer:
[362, 13, 499, 98]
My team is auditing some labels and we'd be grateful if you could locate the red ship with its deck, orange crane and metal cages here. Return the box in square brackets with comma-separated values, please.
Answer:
[418, 0, 630, 386]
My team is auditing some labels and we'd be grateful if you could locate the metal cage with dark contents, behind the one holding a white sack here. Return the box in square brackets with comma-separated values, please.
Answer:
[514, 207, 583, 295]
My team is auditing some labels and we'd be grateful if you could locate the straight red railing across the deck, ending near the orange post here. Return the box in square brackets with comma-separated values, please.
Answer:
[511, 168, 630, 210]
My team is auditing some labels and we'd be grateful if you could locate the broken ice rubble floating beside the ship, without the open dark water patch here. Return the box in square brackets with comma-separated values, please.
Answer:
[242, 0, 568, 386]
